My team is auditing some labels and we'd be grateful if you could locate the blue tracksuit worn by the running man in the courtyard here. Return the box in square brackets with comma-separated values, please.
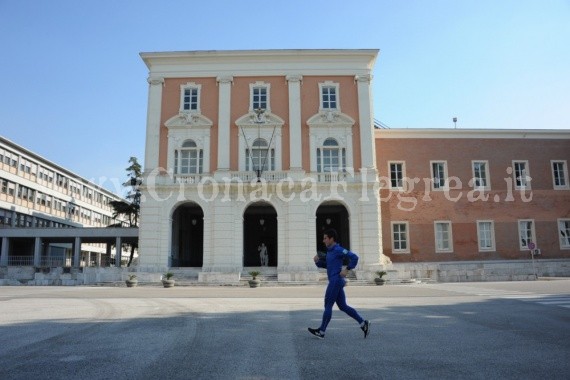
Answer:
[316, 244, 364, 333]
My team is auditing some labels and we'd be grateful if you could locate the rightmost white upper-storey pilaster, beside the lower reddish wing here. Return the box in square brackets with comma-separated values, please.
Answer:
[355, 75, 376, 173]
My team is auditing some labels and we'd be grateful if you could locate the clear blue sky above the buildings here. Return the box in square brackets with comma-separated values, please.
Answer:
[0, 0, 570, 194]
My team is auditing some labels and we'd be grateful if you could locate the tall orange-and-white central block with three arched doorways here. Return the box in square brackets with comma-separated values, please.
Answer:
[140, 50, 383, 282]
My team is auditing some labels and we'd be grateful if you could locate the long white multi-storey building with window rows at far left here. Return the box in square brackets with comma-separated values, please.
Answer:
[0, 137, 130, 267]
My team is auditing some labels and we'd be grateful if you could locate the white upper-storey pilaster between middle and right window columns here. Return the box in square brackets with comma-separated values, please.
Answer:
[287, 75, 303, 171]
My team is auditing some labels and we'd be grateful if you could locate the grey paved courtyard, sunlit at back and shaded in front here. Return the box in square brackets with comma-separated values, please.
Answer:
[0, 280, 570, 380]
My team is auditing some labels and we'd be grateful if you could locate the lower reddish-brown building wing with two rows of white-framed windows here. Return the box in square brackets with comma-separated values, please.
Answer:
[375, 129, 570, 262]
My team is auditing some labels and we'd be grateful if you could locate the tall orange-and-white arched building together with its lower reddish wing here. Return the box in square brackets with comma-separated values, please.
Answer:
[139, 50, 570, 282]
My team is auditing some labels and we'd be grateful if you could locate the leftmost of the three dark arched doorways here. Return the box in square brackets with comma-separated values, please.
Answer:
[170, 203, 204, 267]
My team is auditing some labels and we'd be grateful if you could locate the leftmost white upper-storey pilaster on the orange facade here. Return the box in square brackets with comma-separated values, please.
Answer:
[144, 77, 164, 173]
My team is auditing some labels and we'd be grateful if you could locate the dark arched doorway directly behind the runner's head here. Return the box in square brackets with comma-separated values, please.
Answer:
[316, 202, 350, 252]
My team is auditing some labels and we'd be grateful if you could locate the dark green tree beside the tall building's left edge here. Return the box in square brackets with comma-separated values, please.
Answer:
[109, 157, 142, 266]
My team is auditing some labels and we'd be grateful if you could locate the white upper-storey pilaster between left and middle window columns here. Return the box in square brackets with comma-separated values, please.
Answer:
[217, 76, 233, 171]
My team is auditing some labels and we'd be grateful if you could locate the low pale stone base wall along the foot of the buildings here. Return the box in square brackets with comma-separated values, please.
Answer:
[0, 259, 570, 286]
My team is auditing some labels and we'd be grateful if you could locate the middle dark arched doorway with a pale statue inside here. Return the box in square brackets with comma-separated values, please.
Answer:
[243, 202, 278, 267]
